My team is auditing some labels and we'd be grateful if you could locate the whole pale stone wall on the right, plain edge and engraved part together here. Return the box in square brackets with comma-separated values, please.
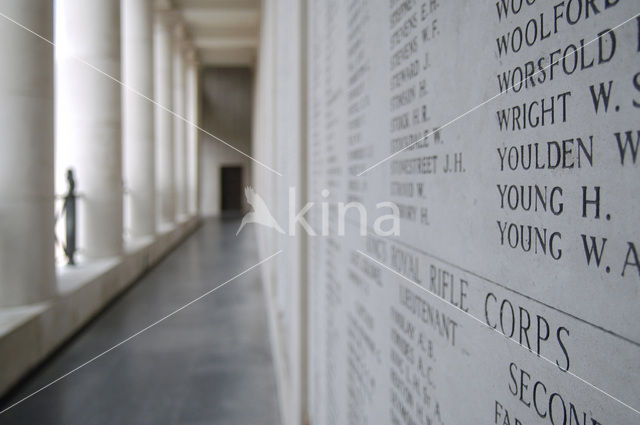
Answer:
[253, 0, 640, 425]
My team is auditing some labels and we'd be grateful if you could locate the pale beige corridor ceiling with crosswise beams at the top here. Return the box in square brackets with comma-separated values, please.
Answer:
[173, 0, 260, 66]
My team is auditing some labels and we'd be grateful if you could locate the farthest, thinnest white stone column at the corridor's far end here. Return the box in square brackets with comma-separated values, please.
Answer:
[187, 53, 199, 216]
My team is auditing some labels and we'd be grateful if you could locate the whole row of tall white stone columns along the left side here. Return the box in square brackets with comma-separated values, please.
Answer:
[0, 0, 198, 306]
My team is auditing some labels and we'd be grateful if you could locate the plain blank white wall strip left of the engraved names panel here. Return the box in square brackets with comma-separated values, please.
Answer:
[253, 0, 308, 425]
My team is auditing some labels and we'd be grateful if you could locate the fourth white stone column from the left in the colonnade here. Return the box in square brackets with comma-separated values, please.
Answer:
[153, 1, 176, 227]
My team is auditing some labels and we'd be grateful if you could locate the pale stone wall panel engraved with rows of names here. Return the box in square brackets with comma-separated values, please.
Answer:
[302, 0, 640, 425]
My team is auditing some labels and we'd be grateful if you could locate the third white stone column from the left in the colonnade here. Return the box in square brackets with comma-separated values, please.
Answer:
[121, 0, 156, 237]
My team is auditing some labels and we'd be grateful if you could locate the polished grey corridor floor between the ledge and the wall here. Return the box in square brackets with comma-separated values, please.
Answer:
[0, 219, 279, 425]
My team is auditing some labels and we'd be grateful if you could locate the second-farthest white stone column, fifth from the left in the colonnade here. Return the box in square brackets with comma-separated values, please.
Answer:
[173, 22, 187, 221]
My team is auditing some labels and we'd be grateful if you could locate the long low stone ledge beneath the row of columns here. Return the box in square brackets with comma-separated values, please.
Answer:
[0, 217, 199, 395]
